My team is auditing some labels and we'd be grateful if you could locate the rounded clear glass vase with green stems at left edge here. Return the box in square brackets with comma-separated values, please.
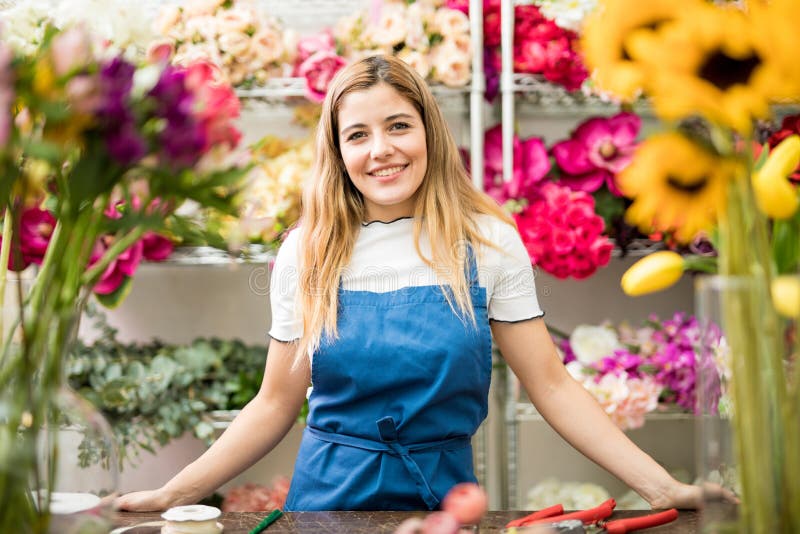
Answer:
[0, 279, 119, 534]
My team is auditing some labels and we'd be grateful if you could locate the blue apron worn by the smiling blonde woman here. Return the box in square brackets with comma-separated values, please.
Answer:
[285, 254, 492, 511]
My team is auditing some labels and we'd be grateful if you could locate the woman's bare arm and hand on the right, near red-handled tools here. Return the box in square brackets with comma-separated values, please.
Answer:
[492, 319, 701, 508]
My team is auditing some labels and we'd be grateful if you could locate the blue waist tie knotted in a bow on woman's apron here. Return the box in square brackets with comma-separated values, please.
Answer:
[306, 417, 470, 510]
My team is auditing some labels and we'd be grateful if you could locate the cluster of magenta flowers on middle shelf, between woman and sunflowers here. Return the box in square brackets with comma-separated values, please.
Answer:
[476, 112, 641, 278]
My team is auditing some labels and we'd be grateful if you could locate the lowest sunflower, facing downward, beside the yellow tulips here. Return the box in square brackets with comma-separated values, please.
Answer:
[617, 132, 740, 243]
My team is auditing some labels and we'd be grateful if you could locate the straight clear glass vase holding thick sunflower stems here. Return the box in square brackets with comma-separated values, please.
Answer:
[695, 276, 800, 533]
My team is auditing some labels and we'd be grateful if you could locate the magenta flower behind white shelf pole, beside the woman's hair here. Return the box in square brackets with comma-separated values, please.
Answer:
[484, 124, 550, 204]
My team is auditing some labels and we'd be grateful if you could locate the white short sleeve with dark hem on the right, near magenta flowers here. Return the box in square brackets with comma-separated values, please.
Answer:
[481, 219, 544, 322]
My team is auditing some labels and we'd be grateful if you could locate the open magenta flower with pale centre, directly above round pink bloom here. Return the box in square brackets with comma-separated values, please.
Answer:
[552, 112, 641, 196]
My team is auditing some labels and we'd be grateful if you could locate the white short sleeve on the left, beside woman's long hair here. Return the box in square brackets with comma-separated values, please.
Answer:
[269, 230, 303, 341]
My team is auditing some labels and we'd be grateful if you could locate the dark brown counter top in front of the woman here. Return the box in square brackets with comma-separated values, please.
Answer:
[117, 511, 698, 534]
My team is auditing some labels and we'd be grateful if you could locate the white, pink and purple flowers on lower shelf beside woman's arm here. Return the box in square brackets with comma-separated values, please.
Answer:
[557, 313, 721, 430]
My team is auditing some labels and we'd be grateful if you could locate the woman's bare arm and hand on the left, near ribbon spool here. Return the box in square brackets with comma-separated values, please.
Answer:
[116, 339, 310, 512]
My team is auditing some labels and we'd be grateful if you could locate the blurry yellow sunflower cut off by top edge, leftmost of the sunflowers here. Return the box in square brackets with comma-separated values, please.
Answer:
[581, 0, 702, 100]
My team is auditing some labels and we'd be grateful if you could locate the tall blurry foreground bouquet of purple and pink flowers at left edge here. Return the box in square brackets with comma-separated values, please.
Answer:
[0, 23, 248, 532]
